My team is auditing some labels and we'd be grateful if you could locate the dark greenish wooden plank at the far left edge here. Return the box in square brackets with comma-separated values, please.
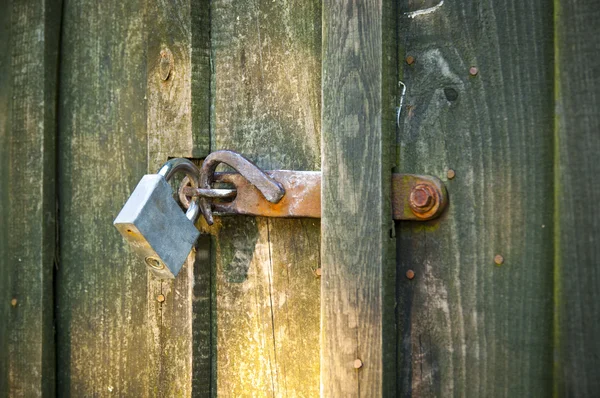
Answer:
[0, 0, 61, 397]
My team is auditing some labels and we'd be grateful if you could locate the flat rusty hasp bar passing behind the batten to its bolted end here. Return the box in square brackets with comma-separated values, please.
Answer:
[181, 170, 448, 221]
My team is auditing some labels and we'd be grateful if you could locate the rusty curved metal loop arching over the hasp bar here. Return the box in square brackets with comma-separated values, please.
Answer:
[199, 151, 285, 225]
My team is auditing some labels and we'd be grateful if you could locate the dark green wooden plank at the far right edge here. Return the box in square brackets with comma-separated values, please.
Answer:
[554, 0, 600, 397]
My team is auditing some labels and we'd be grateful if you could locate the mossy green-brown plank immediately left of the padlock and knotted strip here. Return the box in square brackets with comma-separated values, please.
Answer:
[56, 0, 152, 397]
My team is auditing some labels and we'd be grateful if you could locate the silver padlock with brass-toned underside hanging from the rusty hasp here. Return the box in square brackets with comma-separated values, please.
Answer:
[114, 158, 200, 279]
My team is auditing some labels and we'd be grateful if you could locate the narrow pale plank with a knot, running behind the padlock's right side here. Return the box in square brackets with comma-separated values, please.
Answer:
[145, 0, 212, 397]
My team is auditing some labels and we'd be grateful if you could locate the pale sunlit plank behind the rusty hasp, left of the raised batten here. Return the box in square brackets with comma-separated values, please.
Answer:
[211, 0, 321, 396]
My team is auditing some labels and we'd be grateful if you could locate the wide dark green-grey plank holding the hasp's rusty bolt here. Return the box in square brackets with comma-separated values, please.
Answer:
[397, 0, 554, 397]
